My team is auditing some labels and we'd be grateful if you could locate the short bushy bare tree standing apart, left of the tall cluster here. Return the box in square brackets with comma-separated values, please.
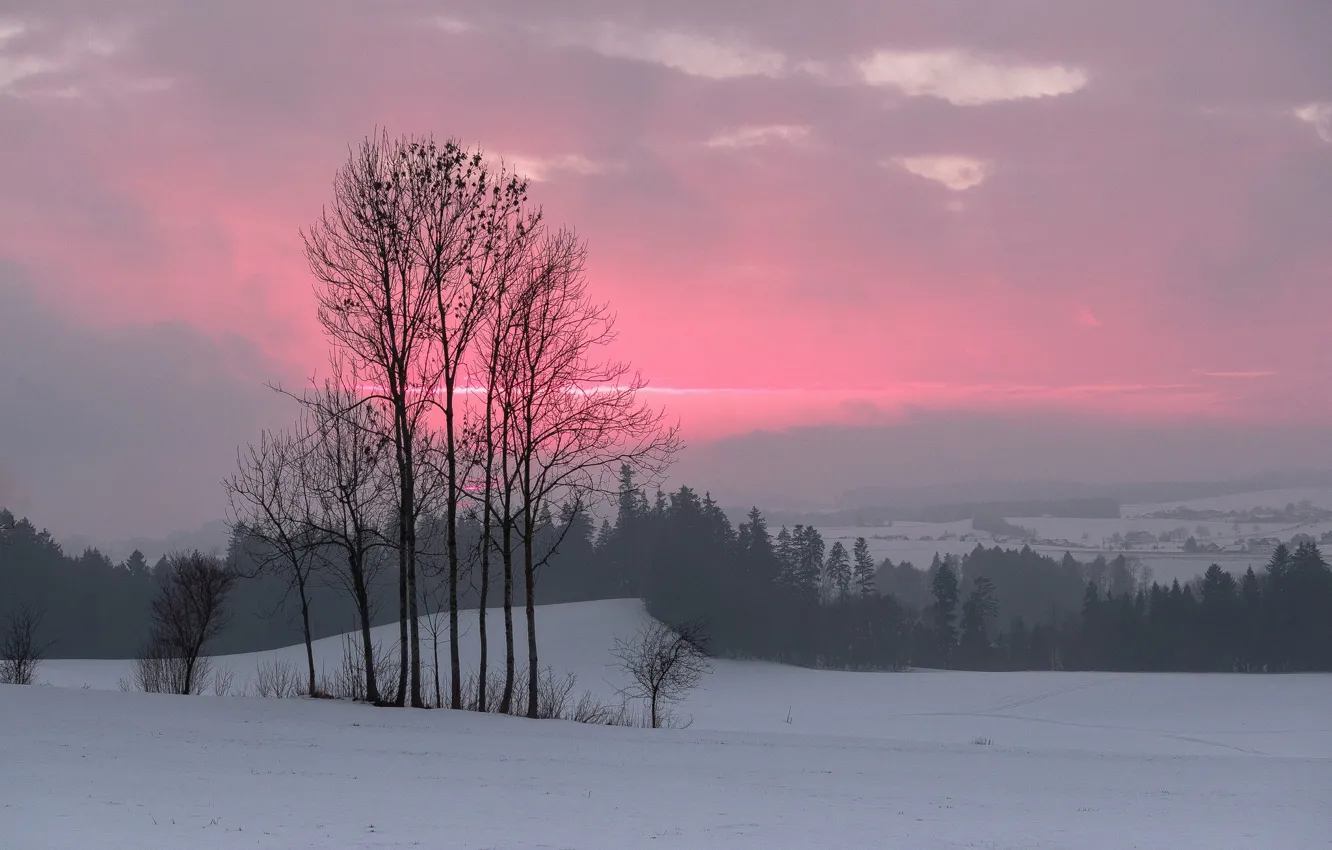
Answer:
[137, 549, 237, 694]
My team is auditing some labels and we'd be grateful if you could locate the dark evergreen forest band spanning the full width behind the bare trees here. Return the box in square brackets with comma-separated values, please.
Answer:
[0, 472, 1332, 671]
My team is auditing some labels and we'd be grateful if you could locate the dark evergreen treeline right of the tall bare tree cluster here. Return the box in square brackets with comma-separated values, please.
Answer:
[597, 474, 1332, 671]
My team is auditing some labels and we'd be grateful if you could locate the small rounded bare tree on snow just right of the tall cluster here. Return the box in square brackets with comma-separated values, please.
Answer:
[613, 620, 711, 729]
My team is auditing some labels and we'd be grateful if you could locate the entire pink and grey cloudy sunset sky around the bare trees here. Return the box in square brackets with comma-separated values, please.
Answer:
[0, 0, 1332, 536]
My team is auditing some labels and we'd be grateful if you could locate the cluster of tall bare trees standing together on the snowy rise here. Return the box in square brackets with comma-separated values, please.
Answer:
[226, 133, 678, 717]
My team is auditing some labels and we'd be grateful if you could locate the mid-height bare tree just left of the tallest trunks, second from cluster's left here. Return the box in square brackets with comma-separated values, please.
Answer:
[301, 370, 394, 703]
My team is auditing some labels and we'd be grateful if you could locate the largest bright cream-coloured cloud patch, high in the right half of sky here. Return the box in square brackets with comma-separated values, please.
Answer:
[856, 51, 1088, 107]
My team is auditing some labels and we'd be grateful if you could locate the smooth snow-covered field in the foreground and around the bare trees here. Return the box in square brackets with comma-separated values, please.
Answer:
[0, 601, 1332, 850]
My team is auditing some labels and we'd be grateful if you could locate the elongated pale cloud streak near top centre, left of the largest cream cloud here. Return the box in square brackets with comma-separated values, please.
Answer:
[541, 21, 786, 80]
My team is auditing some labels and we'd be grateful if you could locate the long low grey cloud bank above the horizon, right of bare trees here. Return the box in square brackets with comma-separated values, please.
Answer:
[671, 410, 1332, 509]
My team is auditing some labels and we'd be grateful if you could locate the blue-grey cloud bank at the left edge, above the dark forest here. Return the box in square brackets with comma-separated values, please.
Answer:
[0, 262, 293, 540]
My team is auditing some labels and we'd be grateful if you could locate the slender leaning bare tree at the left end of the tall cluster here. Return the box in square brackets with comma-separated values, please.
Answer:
[222, 432, 320, 695]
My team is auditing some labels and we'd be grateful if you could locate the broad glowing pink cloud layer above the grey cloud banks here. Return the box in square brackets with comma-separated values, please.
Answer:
[0, 1, 1332, 447]
